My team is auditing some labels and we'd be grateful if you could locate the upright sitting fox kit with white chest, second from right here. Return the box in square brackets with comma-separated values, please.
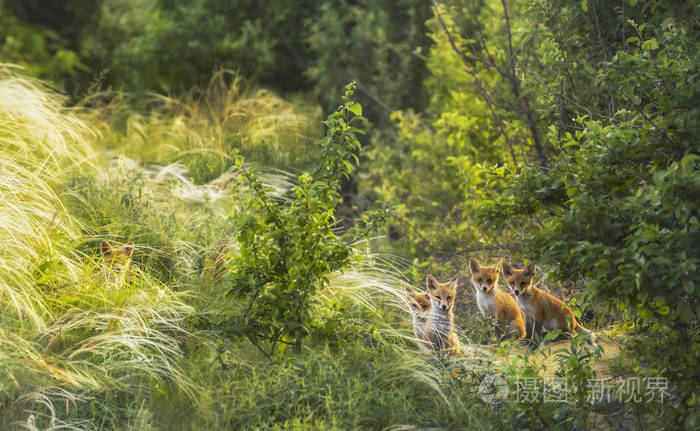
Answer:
[469, 259, 526, 340]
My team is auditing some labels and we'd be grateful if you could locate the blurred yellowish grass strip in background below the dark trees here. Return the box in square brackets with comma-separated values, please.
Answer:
[85, 70, 320, 184]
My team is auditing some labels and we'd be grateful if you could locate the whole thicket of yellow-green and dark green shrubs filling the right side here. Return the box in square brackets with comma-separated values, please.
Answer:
[364, 0, 700, 427]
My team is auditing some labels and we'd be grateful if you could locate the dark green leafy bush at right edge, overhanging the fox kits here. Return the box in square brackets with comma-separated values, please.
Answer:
[480, 4, 700, 427]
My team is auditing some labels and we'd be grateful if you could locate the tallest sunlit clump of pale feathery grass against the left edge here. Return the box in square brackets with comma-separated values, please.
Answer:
[0, 71, 92, 328]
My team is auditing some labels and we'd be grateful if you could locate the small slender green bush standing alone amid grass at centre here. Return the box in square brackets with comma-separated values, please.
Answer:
[220, 85, 362, 354]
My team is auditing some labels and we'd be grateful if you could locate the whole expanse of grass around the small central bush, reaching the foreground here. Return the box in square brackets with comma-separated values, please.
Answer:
[0, 66, 612, 430]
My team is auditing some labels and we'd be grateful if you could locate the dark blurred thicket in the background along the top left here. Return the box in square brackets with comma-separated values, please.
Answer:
[0, 0, 430, 122]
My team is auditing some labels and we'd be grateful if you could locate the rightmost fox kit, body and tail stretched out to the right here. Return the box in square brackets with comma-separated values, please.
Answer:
[503, 263, 597, 346]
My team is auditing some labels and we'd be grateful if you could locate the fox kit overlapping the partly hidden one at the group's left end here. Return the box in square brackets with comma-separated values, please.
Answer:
[426, 275, 461, 355]
